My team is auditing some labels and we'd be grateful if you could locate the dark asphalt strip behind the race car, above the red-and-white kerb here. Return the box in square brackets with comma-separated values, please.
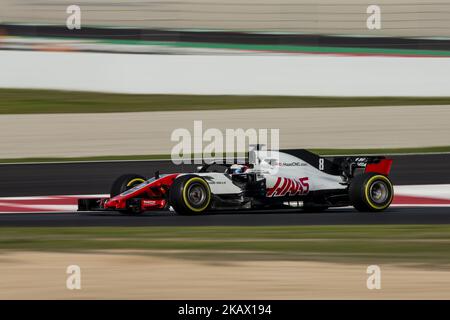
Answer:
[0, 154, 450, 197]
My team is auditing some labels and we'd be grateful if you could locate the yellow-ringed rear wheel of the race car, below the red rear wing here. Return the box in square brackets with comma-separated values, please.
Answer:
[349, 172, 394, 212]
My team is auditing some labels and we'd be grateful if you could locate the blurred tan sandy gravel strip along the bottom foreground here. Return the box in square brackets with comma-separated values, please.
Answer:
[0, 251, 450, 299]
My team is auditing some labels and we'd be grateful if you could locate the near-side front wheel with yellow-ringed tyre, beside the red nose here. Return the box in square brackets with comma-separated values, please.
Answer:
[169, 175, 212, 215]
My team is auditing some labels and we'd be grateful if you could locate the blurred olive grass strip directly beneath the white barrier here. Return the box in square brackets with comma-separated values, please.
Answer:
[0, 89, 450, 114]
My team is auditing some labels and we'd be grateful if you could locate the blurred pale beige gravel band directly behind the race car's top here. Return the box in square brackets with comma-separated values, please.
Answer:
[0, 106, 450, 158]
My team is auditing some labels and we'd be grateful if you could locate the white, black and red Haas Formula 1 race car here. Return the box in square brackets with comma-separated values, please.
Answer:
[78, 150, 393, 215]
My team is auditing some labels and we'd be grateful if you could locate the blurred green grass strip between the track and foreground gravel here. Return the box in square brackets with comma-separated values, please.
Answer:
[0, 224, 450, 267]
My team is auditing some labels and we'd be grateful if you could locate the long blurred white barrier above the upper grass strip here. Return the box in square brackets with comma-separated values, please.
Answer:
[0, 51, 450, 96]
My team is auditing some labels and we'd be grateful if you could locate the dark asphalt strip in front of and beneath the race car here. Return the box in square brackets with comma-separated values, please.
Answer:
[0, 207, 450, 227]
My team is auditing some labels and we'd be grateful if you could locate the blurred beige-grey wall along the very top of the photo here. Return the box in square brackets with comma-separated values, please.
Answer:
[0, 0, 450, 37]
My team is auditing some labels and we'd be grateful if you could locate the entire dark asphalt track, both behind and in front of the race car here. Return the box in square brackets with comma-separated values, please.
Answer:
[0, 154, 450, 227]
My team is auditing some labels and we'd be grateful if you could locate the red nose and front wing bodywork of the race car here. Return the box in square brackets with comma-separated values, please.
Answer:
[101, 173, 180, 211]
